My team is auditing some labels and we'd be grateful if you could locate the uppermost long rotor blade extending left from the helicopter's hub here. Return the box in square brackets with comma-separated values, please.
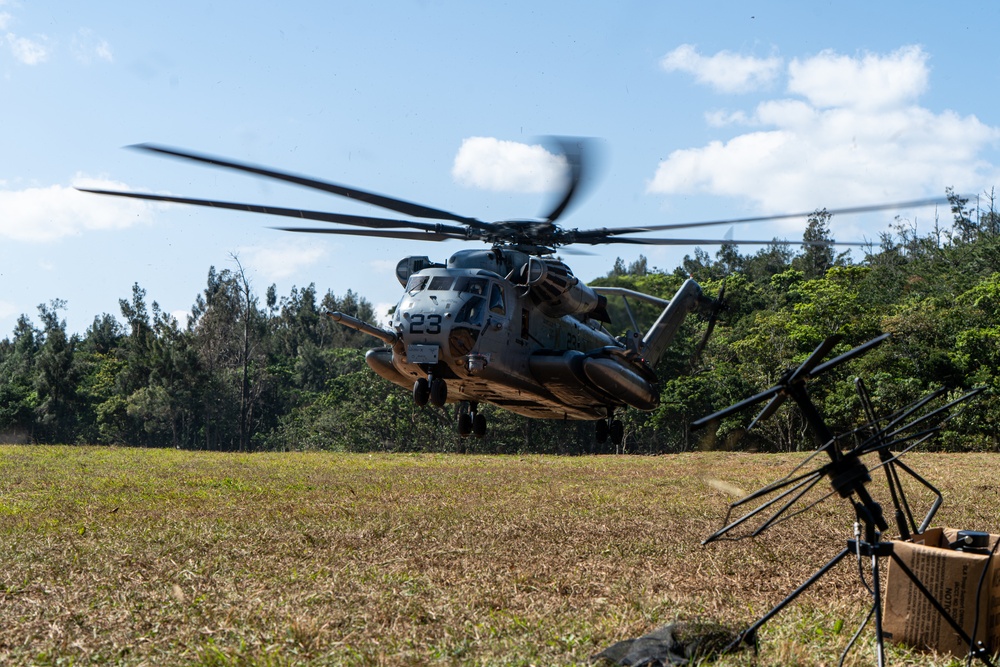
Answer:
[130, 144, 492, 230]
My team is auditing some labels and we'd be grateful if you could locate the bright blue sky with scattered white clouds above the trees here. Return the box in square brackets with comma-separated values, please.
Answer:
[0, 0, 1000, 337]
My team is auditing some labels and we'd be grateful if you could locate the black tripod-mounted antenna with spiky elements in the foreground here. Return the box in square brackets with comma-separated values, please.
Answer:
[692, 334, 993, 667]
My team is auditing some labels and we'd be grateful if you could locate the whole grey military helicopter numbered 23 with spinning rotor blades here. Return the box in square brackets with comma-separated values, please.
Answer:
[80, 138, 944, 445]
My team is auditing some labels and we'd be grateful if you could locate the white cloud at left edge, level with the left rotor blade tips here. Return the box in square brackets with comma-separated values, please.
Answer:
[0, 176, 153, 242]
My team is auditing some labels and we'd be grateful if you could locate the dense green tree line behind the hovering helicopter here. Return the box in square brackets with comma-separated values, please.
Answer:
[0, 195, 1000, 453]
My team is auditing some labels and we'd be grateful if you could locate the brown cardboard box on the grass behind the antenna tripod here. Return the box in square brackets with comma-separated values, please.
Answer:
[882, 528, 1000, 657]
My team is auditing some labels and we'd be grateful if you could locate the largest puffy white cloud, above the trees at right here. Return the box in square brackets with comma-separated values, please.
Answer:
[648, 47, 1000, 213]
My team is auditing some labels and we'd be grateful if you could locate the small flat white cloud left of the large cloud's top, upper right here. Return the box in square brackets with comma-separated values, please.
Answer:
[660, 44, 782, 93]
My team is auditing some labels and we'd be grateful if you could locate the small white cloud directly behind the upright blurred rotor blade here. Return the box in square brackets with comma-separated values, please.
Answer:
[451, 137, 567, 192]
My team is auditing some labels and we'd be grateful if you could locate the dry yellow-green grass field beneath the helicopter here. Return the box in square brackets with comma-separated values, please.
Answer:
[0, 446, 1000, 665]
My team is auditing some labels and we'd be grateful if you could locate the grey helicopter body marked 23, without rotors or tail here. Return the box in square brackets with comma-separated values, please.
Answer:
[352, 249, 687, 420]
